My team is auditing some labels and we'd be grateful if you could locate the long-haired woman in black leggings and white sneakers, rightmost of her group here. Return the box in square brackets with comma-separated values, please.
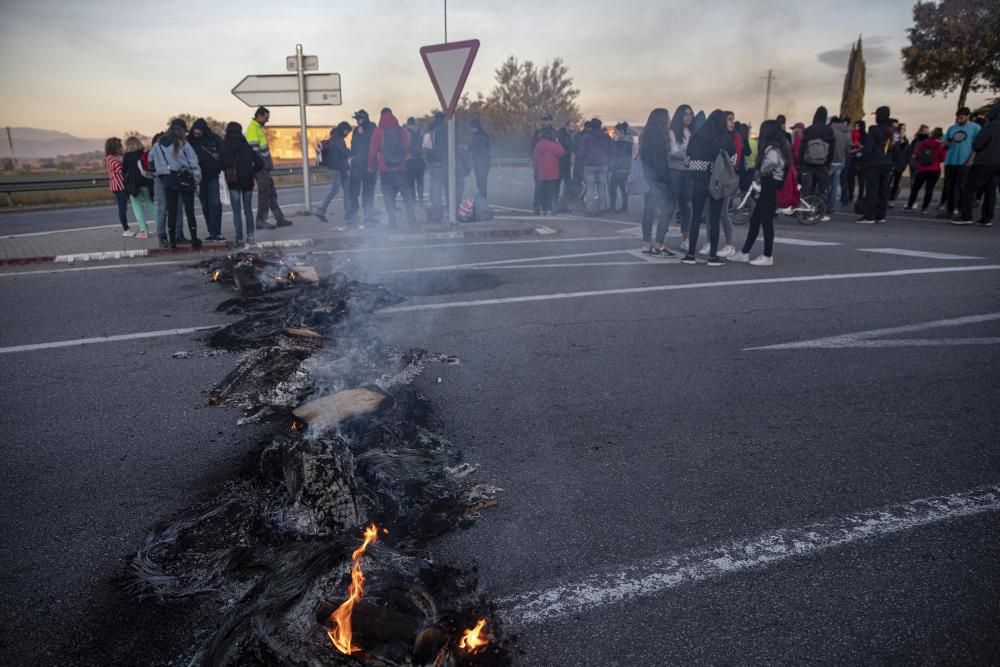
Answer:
[732, 120, 791, 266]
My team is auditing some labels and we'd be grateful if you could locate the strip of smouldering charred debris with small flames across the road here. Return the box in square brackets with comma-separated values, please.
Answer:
[130, 253, 510, 667]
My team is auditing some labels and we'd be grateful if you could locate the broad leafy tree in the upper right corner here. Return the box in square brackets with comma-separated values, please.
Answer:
[903, 0, 1000, 107]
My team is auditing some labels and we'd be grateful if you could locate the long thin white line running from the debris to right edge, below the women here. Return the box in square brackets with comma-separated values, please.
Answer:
[378, 264, 1000, 314]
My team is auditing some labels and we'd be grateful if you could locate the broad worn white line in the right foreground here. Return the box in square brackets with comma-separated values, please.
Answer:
[497, 484, 1000, 627]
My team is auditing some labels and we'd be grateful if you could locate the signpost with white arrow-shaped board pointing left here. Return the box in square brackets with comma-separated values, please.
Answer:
[232, 44, 342, 211]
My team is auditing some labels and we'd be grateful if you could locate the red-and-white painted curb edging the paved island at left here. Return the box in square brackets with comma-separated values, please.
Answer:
[0, 226, 558, 266]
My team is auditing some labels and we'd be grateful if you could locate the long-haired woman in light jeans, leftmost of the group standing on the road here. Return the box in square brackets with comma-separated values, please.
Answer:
[639, 108, 675, 258]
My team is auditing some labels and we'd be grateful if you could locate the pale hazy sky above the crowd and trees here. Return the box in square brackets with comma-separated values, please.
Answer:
[0, 0, 986, 137]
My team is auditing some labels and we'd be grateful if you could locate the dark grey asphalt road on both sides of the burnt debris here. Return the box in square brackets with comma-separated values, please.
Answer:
[0, 172, 1000, 665]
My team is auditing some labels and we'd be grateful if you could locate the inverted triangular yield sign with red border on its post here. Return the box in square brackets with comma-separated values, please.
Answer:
[420, 37, 479, 224]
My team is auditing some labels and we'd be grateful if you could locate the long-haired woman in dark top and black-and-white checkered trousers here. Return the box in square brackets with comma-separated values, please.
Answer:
[681, 109, 736, 266]
